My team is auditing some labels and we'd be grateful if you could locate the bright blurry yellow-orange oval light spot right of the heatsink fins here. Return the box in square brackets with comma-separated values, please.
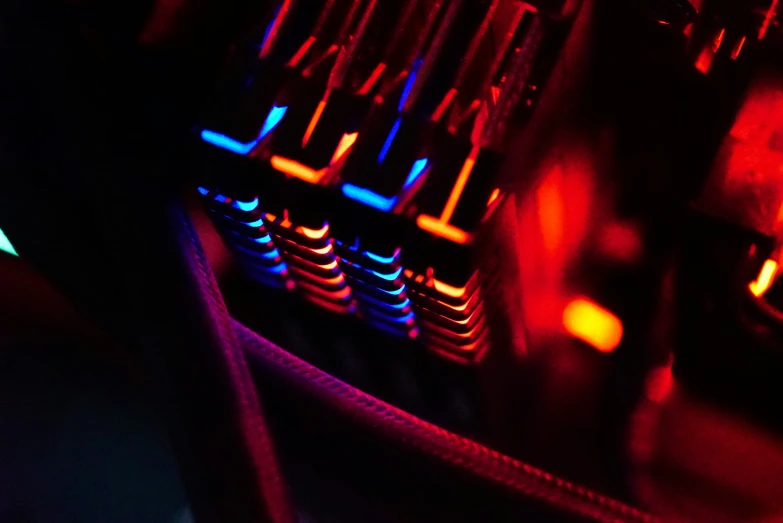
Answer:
[563, 298, 623, 352]
